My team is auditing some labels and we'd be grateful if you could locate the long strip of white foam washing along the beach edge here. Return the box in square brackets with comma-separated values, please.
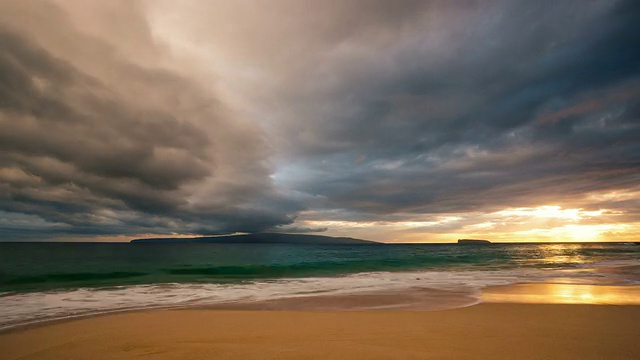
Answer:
[0, 269, 628, 329]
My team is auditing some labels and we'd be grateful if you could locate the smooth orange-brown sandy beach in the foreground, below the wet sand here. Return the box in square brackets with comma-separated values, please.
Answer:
[0, 303, 640, 360]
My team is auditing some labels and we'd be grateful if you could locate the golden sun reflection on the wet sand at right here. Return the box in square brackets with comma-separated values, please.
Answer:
[481, 284, 640, 305]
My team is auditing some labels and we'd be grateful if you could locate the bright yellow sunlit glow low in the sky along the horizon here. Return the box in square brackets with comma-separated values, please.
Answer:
[299, 205, 637, 243]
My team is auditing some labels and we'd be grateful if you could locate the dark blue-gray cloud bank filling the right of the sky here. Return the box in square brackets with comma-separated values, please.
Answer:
[272, 2, 640, 216]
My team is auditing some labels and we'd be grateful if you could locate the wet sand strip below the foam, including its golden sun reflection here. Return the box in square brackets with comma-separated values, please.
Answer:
[0, 282, 640, 336]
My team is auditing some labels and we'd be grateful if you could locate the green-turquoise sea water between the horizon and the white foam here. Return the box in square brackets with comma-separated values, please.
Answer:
[0, 243, 640, 292]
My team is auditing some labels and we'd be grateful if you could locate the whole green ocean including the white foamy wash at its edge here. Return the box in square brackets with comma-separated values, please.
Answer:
[0, 243, 640, 329]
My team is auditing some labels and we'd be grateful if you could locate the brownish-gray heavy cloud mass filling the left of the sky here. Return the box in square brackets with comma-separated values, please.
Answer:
[0, 2, 298, 239]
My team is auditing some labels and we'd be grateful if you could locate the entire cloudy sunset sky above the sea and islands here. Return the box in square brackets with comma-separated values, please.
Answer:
[0, 0, 640, 242]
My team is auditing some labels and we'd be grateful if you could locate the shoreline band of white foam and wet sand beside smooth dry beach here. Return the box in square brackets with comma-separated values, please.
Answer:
[0, 249, 640, 332]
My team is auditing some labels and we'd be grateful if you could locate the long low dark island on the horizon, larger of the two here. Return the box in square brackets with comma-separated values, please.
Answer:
[131, 233, 383, 245]
